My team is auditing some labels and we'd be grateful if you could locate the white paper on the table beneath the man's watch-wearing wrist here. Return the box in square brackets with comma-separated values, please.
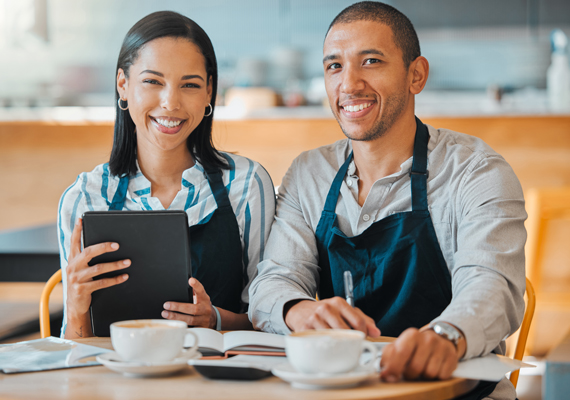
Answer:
[452, 354, 536, 382]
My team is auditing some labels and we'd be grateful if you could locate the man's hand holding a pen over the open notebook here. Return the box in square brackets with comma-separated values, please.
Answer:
[284, 297, 380, 337]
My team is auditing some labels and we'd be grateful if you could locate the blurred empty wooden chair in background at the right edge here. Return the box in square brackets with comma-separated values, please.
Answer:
[525, 187, 570, 356]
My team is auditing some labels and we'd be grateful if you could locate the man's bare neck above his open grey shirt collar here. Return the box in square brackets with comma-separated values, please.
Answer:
[352, 114, 416, 206]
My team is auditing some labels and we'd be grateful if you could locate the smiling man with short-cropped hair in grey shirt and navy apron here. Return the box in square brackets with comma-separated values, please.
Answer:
[249, 2, 526, 398]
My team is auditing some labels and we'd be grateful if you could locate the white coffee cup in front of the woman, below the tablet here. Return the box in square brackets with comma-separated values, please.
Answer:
[111, 319, 198, 363]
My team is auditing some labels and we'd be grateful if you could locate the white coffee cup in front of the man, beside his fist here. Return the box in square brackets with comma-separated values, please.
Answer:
[285, 329, 377, 374]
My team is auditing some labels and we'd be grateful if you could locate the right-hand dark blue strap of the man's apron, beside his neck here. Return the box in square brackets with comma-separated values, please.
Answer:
[410, 118, 429, 211]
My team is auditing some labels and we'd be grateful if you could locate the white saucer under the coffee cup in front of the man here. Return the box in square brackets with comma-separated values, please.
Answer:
[271, 362, 379, 389]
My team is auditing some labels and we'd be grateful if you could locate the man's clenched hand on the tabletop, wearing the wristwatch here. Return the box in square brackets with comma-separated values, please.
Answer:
[380, 328, 465, 382]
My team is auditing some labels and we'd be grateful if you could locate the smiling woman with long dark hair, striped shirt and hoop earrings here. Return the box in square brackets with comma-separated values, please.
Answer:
[58, 11, 275, 338]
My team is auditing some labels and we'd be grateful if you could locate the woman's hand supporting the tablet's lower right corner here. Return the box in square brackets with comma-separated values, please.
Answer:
[162, 278, 217, 329]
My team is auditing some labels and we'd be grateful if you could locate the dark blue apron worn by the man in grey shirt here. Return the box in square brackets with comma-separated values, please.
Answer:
[316, 118, 496, 399]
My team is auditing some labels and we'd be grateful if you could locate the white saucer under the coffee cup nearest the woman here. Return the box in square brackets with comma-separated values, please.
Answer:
[96, 351, 202, 378]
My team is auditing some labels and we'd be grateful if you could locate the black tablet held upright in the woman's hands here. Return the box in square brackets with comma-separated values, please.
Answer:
[83, 210, 192, 336]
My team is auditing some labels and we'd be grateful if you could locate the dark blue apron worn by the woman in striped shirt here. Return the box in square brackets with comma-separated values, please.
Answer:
[109, 166, 244, 313]
